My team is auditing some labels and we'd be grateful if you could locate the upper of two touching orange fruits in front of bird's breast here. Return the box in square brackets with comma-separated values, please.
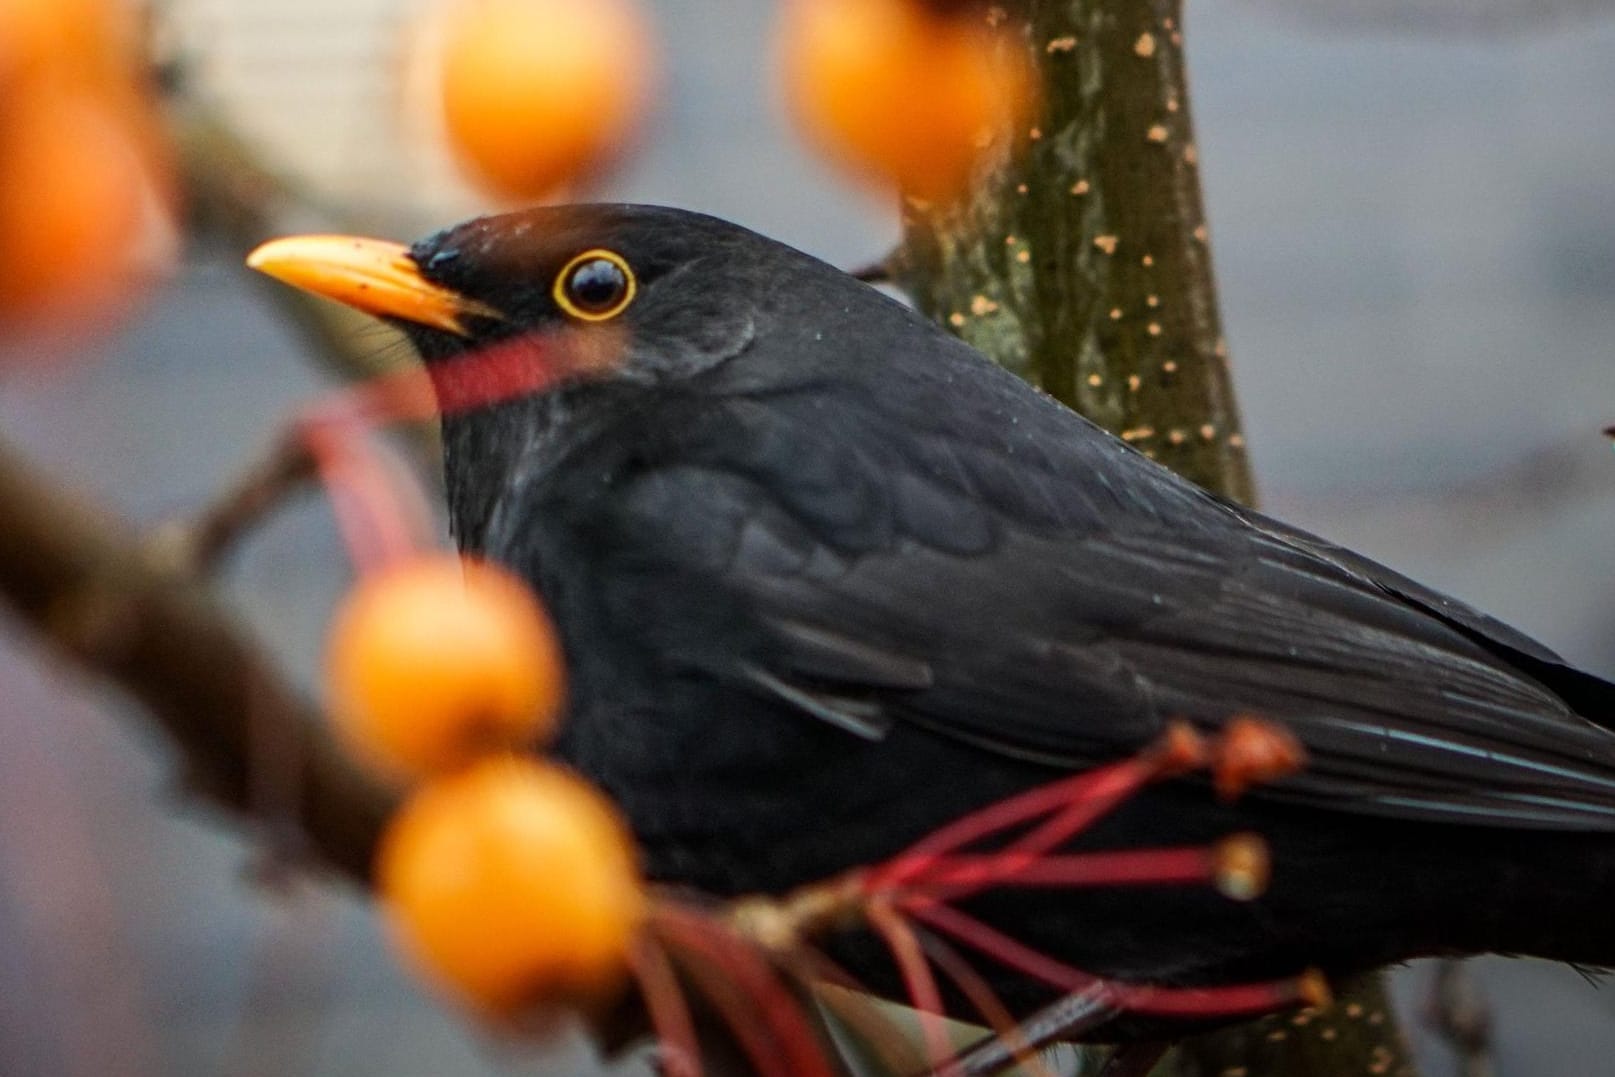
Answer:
[326, 554, 565, 775]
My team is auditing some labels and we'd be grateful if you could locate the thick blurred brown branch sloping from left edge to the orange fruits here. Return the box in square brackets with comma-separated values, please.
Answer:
[0, 432, 397, 885]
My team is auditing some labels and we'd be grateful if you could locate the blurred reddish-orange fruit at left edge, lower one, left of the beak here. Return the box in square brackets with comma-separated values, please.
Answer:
[0, 82, 158, 323]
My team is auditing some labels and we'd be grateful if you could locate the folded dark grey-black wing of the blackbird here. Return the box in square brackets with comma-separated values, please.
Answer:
[562, 349, 1615, 830]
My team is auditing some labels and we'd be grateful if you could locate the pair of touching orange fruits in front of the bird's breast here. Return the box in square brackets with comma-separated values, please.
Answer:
[326, 554, 646, 1016]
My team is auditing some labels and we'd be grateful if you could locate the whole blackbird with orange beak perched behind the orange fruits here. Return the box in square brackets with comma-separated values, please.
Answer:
[254, 205, 1615, 1035]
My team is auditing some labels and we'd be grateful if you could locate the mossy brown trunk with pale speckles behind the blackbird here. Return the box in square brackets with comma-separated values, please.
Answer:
[891, 0, 1412, 1077]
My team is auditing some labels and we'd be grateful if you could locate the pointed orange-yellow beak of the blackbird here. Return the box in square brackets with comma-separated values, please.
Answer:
[247, 236, 502, 336]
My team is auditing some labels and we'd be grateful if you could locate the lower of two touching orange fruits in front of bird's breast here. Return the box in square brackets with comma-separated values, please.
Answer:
[376, 757, 644, 1014]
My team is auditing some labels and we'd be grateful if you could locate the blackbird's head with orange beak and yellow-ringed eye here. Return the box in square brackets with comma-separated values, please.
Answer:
[249, 205, 794, 384]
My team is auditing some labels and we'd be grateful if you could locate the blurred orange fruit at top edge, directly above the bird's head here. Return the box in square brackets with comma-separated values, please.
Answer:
[438, 0, 652, 199]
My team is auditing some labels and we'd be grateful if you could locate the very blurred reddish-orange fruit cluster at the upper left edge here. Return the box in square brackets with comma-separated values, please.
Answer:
[0, 0, 173, 334]
